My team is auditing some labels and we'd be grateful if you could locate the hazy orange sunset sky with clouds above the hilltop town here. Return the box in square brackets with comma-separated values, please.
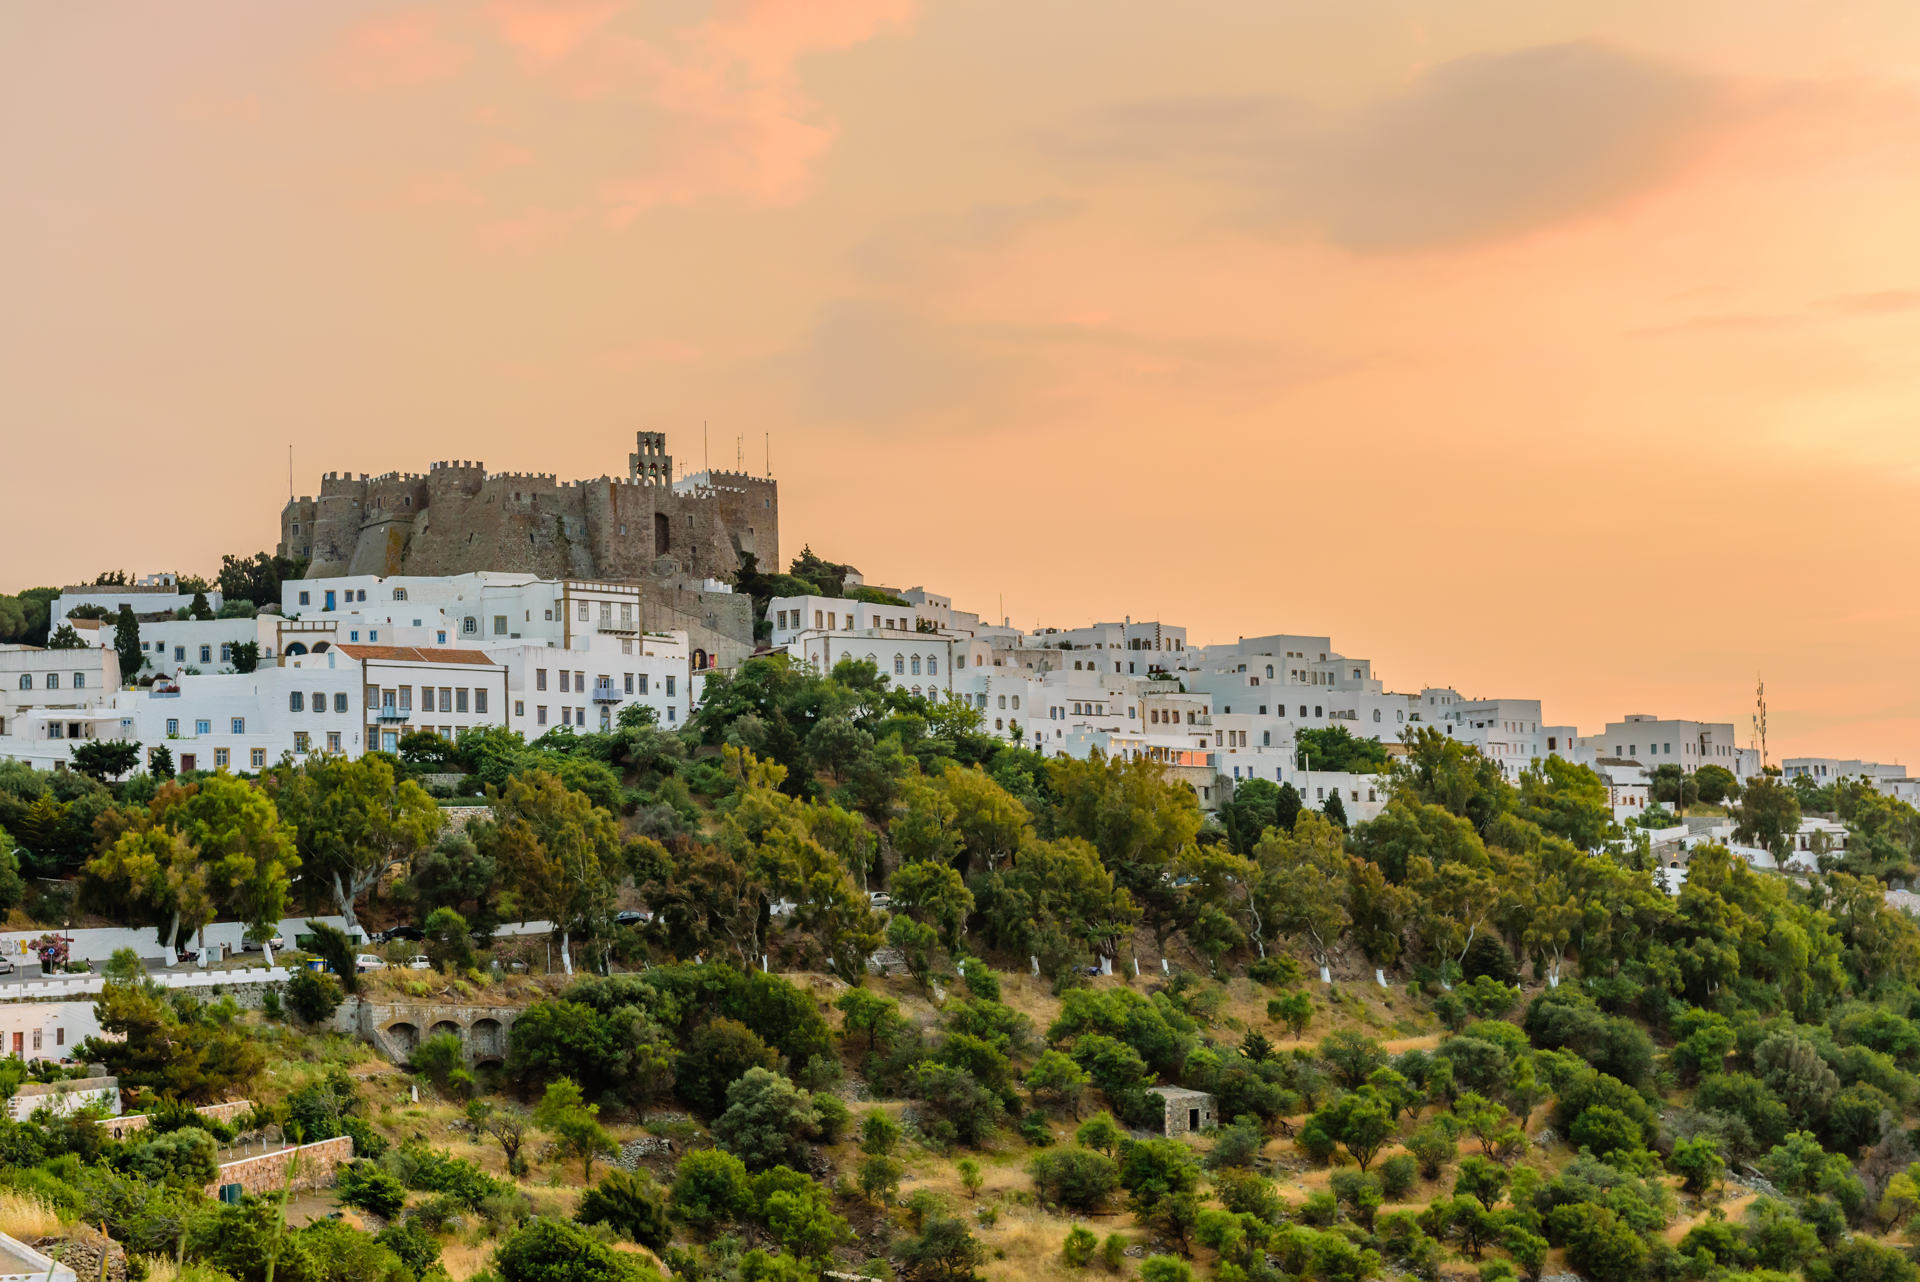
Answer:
[0, 0, 1920, 760]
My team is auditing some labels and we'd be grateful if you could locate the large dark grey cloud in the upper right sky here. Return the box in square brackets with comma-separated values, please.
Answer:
[1089, 42, 1732, 253]
